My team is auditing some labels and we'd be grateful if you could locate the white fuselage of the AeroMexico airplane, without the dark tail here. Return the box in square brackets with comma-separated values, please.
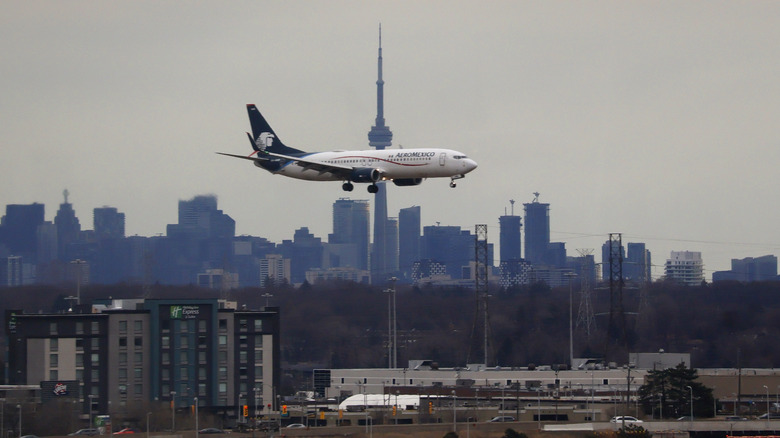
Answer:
[274, 149, 477, 181]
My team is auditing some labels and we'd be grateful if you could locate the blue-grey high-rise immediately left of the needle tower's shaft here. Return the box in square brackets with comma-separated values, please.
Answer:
[328, 198, 370, 270]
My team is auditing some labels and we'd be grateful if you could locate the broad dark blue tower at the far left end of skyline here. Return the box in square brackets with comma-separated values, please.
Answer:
[0, 203, 43, 264]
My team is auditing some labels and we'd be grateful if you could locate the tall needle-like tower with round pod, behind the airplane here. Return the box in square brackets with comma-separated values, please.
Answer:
[368, 26, 398, 284]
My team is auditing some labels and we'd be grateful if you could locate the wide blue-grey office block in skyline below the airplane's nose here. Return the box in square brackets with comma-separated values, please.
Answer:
[420, 225, 476, 279]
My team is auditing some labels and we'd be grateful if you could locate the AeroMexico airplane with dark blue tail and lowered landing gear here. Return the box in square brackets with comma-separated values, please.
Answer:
[217, 104, 477, 193]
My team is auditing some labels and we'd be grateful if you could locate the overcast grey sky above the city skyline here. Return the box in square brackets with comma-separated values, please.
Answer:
[0, 0, 780, 277]
